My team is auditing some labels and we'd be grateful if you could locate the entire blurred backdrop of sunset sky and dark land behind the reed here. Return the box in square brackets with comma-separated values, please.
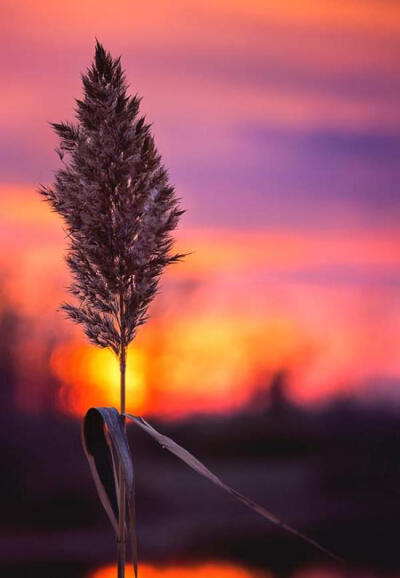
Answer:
[0, 0, 400, 578]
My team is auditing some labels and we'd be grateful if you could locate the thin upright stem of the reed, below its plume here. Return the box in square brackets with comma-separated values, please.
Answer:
[118, 294, 127, 578]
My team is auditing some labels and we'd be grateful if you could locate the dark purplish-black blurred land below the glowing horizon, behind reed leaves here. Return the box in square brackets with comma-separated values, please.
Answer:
[0, 396, 400, 578]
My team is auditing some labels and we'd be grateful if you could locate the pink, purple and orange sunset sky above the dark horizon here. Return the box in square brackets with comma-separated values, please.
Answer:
[0, 0, 400, 415]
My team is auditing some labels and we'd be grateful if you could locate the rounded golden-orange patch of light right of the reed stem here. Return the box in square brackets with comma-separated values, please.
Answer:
[160, 315, 307, 407]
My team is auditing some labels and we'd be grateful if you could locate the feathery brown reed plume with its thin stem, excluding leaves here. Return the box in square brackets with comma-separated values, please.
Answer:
[40, 42, 183, 577]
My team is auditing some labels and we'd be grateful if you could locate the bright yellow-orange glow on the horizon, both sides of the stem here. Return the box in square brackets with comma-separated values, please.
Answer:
[50, 315, 312, 417]
